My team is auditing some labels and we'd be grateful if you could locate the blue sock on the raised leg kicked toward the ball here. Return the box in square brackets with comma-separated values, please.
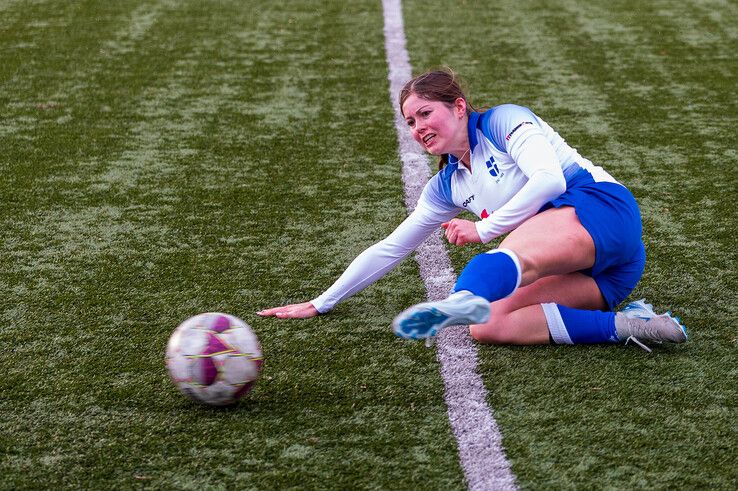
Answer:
[454, 249, 521, 302]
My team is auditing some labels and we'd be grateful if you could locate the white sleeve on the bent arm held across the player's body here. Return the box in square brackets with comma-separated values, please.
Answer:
[476, 132, 566, 244]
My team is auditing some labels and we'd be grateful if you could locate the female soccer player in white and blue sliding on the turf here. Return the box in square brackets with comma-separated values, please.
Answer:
[259, 71, 687, 350]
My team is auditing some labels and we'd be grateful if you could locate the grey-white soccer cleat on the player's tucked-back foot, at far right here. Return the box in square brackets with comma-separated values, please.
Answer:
[616, 298, 688, 353]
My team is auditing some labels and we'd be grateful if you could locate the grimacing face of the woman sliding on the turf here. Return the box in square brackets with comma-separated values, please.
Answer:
[402, 94, 468, 156]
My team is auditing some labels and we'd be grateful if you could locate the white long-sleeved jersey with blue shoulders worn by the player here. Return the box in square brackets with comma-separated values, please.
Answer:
[311, 104, 617, 312]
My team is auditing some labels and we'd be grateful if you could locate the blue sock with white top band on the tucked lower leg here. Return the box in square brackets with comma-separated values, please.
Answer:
[541, 303, 619, 344]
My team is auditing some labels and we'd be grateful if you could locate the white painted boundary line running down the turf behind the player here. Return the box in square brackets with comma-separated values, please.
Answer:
[382, 0, 516, 490]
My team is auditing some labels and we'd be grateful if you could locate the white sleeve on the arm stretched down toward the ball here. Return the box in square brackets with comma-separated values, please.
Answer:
[311, 203, 457, 313]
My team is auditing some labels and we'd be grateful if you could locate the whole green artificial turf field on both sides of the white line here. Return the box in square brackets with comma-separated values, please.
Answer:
[0, 0, 738, 489]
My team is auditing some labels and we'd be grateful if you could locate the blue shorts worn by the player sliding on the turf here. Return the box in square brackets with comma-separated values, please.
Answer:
[542, 166, 646, 310]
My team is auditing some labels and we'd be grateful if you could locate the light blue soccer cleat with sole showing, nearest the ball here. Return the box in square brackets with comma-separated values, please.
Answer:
[392, 291, 490, 339]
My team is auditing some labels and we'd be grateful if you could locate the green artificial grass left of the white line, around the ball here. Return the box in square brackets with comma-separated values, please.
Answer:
[0, 1, 462, 489]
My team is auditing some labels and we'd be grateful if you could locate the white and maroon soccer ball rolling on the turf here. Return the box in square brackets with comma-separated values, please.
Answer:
[167, 312, 263, 406]
